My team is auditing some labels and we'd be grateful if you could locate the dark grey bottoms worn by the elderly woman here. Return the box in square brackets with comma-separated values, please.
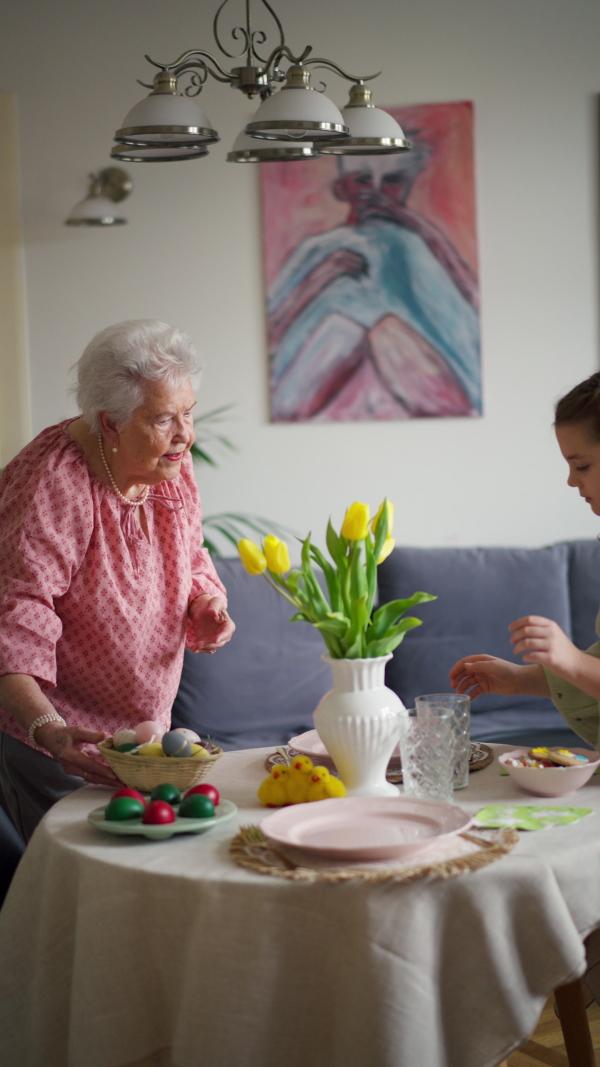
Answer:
[0, 732, 85, 843]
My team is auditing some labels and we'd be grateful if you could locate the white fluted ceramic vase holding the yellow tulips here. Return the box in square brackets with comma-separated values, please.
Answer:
[314, 655, 405, 797]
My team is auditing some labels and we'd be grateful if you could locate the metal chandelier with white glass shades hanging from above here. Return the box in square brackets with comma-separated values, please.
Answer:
[111, 0, 410, 163]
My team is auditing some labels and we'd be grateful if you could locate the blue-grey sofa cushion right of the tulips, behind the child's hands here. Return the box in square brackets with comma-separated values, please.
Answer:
[379, 544, 571, 742]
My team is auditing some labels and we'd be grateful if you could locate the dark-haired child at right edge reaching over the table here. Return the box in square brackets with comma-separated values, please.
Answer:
[449, 372, 600, 748]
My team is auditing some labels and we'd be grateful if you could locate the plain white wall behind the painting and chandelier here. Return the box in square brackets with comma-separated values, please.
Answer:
[0, 0, 600, 545]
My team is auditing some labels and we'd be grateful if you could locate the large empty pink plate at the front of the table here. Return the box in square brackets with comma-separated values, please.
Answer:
[260, 797, 472, 862]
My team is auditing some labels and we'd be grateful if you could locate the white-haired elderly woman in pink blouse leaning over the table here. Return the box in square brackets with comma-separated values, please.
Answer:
[0, 319, 235, 840]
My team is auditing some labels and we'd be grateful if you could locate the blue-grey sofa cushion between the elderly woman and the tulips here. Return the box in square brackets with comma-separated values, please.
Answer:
[172, 559, 331, 749]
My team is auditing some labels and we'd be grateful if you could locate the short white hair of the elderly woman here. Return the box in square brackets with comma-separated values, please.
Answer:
[72, 319, 201, 432]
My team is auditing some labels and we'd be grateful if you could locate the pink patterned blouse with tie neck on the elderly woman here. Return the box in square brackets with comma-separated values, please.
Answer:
[0, 419, 225, 747]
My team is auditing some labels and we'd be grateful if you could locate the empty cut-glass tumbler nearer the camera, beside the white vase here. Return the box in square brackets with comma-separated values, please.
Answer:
[399, 707, 454, 803]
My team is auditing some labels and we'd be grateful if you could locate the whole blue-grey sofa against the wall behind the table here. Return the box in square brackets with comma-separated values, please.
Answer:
[173, 541, 600, 749]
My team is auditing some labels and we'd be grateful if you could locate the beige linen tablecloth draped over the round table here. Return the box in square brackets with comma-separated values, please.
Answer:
[0, 746, 600, 1067]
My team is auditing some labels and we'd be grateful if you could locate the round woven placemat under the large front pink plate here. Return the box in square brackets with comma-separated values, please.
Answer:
[230, 825, 519, 883]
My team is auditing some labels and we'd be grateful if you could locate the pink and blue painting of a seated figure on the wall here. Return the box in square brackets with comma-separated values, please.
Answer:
[260, 101, 481, 423]
